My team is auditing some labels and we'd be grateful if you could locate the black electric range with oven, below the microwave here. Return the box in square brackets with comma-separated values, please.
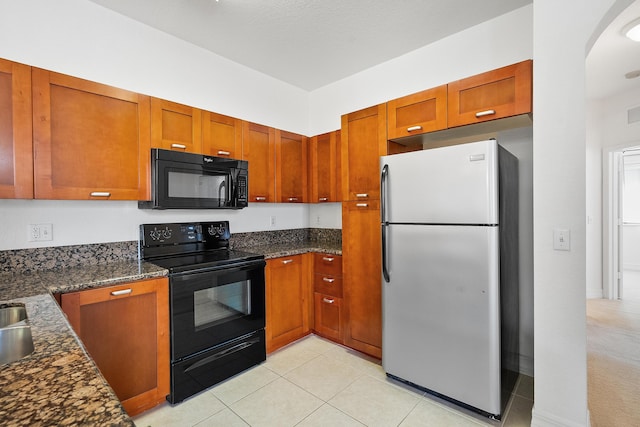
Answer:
[139, 221, 266, 404]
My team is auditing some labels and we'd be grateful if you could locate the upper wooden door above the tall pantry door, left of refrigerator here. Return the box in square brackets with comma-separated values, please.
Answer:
[341, 104, 387, 200]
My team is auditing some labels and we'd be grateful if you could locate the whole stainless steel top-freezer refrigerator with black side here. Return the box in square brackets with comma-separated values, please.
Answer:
[380, 140, 519, 418]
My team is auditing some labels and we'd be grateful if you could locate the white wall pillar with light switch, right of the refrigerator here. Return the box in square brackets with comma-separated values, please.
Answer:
[532, 0, 630, 426]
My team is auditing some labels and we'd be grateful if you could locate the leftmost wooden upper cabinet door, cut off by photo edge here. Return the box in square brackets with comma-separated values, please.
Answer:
[0, 59, 33, 199]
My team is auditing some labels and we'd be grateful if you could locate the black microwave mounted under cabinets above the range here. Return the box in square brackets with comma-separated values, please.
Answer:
[138, 148, 249, 209]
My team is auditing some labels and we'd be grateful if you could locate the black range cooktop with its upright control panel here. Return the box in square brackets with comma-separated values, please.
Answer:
[139, 221, 264, 273]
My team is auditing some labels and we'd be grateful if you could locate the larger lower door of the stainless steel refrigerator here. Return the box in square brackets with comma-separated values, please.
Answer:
[382, 224, 501, 415]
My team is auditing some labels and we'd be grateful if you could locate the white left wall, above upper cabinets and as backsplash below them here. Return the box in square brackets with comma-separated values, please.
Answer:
[0, 0, 320, 250]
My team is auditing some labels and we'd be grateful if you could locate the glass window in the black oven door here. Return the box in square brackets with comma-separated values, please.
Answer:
[193, 280, 251, 331]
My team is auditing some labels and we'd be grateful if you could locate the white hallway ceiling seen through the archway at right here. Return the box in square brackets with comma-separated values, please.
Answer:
[586, 0, 640, 103]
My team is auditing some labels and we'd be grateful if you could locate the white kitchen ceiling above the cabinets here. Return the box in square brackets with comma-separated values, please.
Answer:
[91, 0, 532, 91]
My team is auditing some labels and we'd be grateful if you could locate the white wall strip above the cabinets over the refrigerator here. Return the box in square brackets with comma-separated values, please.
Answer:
[310, 6, 533, 135]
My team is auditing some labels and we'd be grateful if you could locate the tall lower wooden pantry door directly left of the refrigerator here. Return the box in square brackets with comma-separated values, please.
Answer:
[342, 200, 382, 357]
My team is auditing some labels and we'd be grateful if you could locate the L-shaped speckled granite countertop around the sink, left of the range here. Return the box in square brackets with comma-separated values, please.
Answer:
[0, 261, 167, 426]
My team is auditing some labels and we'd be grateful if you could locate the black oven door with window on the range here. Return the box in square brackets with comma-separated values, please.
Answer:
[169, 260, 266, 362]
